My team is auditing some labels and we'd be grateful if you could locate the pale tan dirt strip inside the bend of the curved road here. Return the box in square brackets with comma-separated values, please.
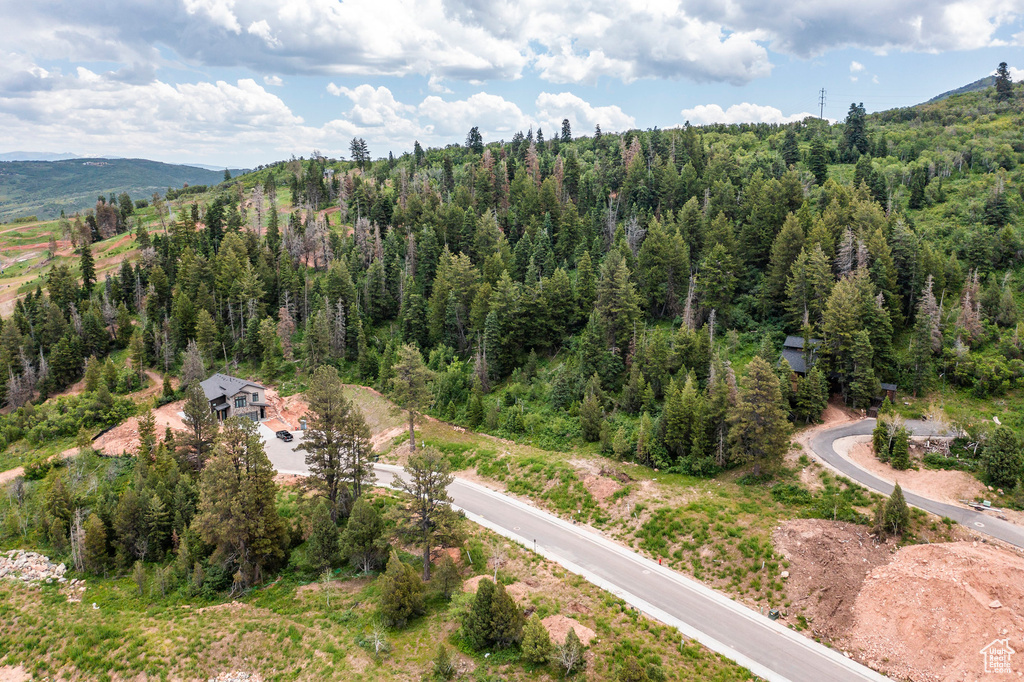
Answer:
[834, 435, 986, 505]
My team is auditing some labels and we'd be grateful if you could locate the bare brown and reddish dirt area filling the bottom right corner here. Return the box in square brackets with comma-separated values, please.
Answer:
[773, 519, 1024, 682]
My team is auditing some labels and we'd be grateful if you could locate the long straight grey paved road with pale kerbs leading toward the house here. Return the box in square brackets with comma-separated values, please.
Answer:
[264, 429, 887, 682]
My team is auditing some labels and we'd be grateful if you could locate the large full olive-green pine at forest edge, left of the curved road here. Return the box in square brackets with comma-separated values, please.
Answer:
[729, 357, 790, 476]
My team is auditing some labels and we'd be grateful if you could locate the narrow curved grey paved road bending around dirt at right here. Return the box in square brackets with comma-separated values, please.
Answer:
[811, 419, 1024, 548]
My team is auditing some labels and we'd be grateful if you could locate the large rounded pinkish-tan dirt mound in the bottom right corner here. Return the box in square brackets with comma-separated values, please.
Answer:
[849, 542, 1024, 682]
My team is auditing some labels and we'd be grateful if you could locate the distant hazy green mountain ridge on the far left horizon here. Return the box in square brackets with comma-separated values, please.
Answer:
[0, 159, 243, 221]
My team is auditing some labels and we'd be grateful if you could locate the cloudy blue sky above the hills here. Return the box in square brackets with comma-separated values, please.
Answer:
[0, 0, 1024, 168]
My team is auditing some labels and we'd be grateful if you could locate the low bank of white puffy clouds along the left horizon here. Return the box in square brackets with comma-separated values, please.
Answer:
[0, 53, 634, 165]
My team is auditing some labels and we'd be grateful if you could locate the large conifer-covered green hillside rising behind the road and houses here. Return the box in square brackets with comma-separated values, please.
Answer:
[0, 74, 1024, 475]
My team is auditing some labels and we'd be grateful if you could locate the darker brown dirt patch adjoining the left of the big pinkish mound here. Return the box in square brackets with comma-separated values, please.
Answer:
[772, 519, 894, 640]
